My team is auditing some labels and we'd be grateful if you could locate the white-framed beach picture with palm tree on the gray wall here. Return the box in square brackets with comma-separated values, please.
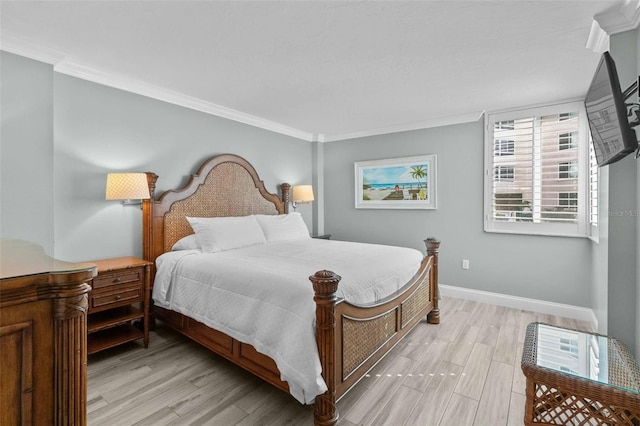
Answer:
[355, 155, 437, 209]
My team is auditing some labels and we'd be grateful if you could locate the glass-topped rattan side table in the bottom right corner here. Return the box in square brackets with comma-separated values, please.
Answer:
[521, 323, 640, 425]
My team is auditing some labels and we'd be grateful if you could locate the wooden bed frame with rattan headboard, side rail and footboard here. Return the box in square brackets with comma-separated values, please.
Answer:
[143, 154, 440, 425]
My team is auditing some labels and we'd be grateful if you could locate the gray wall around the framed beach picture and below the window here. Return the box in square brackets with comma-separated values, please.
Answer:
[324, 120, 591, 307]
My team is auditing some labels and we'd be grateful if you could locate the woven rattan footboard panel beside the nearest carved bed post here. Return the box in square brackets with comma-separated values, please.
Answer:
[342, 310, 397, 379]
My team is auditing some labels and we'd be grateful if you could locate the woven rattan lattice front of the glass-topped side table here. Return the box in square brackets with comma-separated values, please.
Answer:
[532, 383, 640, 426]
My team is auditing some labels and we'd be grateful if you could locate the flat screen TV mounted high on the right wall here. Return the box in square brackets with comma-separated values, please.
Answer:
[584, 52, 638, 167]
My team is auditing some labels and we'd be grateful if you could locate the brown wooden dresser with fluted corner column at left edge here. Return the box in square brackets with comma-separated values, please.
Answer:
[0, 239, 96, 426]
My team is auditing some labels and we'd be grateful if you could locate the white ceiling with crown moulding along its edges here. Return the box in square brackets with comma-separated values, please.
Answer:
[0, 0, 638, 141]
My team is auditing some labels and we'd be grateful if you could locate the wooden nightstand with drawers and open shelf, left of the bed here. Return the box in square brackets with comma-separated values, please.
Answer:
[87, 257, 151, 354]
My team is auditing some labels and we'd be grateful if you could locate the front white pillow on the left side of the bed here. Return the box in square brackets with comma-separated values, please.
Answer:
[187, 216, 266, 253]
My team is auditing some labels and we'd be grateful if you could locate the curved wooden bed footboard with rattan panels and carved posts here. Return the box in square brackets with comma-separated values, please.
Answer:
[309, 238, 440, 426]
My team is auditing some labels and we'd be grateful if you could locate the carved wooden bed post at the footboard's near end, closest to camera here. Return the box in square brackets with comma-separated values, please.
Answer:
[309, 270, 342, 426]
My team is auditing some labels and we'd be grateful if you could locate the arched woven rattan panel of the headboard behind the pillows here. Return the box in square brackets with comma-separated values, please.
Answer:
[164, 163, 278, 251]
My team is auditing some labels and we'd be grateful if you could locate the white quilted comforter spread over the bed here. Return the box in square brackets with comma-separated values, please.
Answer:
[153, 239, 423, 404]
